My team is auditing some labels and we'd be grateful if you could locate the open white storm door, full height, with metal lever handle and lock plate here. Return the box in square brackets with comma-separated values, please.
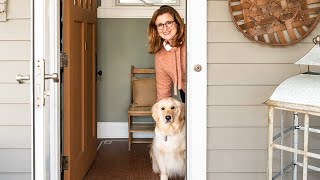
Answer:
[31, 0, 61, 180]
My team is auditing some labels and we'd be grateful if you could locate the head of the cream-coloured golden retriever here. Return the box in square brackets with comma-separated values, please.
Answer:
[152, 97, 184, 125]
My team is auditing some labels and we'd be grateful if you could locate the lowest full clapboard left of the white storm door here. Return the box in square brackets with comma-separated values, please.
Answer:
[0, 148, 31, 173]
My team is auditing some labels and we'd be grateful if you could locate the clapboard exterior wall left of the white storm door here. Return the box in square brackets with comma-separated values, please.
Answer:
[0, 0, 32, 180]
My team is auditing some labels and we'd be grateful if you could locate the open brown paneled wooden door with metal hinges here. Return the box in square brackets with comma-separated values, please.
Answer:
[63, 0, 97, 180]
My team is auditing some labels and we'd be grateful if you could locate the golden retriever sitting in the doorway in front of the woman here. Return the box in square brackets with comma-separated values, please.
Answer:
[150, 97, 186, 180]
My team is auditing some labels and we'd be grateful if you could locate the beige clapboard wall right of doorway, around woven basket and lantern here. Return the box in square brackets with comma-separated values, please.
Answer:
[207, 0, 320, 180]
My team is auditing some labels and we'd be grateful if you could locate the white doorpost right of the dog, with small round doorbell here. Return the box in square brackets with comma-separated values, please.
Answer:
[187, 0, 207, 180]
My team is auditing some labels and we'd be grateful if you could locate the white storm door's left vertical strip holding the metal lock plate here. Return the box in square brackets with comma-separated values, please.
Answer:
[32, 0, 49, 180]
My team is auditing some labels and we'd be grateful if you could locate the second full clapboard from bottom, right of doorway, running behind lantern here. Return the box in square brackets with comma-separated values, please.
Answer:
[208, 127, 320, 151]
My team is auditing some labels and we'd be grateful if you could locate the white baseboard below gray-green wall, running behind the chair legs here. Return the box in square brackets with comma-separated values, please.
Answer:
[97, 122, 154, 138]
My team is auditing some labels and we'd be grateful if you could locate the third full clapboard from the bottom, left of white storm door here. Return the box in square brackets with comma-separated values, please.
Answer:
[0, 103, 31, 126]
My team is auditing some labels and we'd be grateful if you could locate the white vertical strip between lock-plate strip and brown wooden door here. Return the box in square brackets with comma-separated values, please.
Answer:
[46, 0, 62, 180]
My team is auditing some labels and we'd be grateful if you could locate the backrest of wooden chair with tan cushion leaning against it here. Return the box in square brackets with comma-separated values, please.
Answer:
[131, 66, 157, 107]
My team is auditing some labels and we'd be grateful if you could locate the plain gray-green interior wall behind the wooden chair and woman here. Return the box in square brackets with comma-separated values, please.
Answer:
[97, 18, 154, 122]
